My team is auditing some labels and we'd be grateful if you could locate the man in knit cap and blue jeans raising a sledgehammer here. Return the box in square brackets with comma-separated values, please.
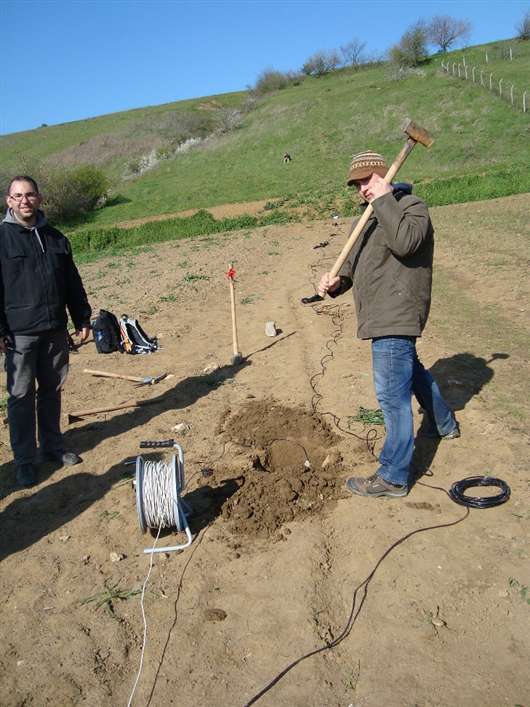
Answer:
[318, 151, 460, 496]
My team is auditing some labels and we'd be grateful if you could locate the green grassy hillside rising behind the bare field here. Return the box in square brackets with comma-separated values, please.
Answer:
[0, 41, 530, 232]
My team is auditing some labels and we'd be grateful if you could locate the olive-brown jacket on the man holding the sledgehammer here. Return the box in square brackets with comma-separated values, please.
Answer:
[331, 191, 434, 339]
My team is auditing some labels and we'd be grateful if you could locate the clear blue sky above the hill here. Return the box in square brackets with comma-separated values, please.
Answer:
[0, 0, 530, 134]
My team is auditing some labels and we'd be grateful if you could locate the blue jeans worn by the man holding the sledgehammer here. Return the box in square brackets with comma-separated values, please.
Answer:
[372, 336, 456, 486]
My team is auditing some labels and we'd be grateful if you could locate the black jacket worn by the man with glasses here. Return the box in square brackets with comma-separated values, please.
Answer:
[0, 212, 91, 337]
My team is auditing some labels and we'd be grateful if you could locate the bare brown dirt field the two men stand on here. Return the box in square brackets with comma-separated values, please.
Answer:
[0, 195, 530, 707]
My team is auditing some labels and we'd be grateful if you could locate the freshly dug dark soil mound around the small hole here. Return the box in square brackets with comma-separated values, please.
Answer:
[207, 400, 343, 536]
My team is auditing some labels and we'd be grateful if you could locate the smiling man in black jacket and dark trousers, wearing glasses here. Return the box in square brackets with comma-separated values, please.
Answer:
[0, 175, 91, 486]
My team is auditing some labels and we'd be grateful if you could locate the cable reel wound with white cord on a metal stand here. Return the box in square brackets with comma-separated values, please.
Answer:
[134, 439, 193, 554]
